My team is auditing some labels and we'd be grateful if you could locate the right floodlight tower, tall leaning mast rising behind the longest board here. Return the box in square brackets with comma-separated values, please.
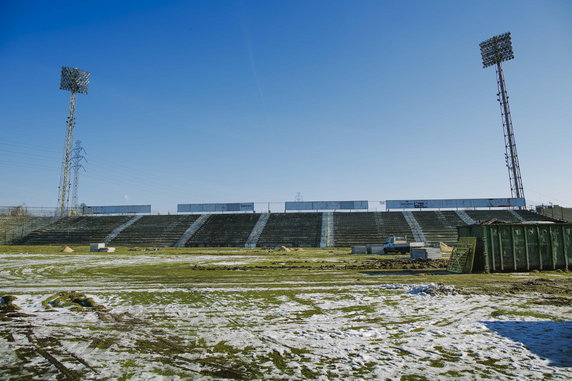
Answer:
[479, 32, 524, 203]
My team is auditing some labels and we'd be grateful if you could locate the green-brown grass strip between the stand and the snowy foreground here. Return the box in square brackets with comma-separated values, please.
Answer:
[0, 245, 572, 294]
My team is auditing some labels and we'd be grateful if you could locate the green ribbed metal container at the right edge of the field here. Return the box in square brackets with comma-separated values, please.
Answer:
[457, 224, 572, 272]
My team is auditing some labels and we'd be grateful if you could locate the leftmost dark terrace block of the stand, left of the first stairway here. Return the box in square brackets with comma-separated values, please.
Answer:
[15, 216, 132, 245]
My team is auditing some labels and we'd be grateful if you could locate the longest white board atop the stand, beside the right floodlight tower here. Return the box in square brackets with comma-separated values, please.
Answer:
[385, 198, 526, 209]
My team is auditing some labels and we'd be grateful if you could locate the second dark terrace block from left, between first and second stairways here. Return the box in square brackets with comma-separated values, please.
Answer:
[110, 214, 199, 246]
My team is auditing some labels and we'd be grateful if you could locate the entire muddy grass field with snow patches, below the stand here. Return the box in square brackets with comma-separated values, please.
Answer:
[0, 246, 572, 380]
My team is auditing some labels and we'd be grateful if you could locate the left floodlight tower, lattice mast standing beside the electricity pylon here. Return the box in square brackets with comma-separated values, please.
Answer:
[58, 67, 89, 216]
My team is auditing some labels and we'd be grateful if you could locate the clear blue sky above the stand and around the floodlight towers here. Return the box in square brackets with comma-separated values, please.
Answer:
[0, 0, 572, 212]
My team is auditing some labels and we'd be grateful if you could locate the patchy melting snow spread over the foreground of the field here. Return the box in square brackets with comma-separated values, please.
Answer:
[0, 251, 572, 380]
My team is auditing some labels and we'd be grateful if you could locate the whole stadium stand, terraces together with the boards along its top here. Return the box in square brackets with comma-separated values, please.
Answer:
[0, 199, 561, 247]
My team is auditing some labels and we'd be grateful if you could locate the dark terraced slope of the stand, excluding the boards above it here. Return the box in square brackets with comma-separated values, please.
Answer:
[8, 209, 552, 247]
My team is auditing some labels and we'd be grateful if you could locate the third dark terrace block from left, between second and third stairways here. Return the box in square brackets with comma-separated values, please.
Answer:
[185, 213, 260, 247]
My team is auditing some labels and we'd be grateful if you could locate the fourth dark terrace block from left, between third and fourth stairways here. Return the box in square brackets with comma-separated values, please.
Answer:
[256, 213, 322, 247]
